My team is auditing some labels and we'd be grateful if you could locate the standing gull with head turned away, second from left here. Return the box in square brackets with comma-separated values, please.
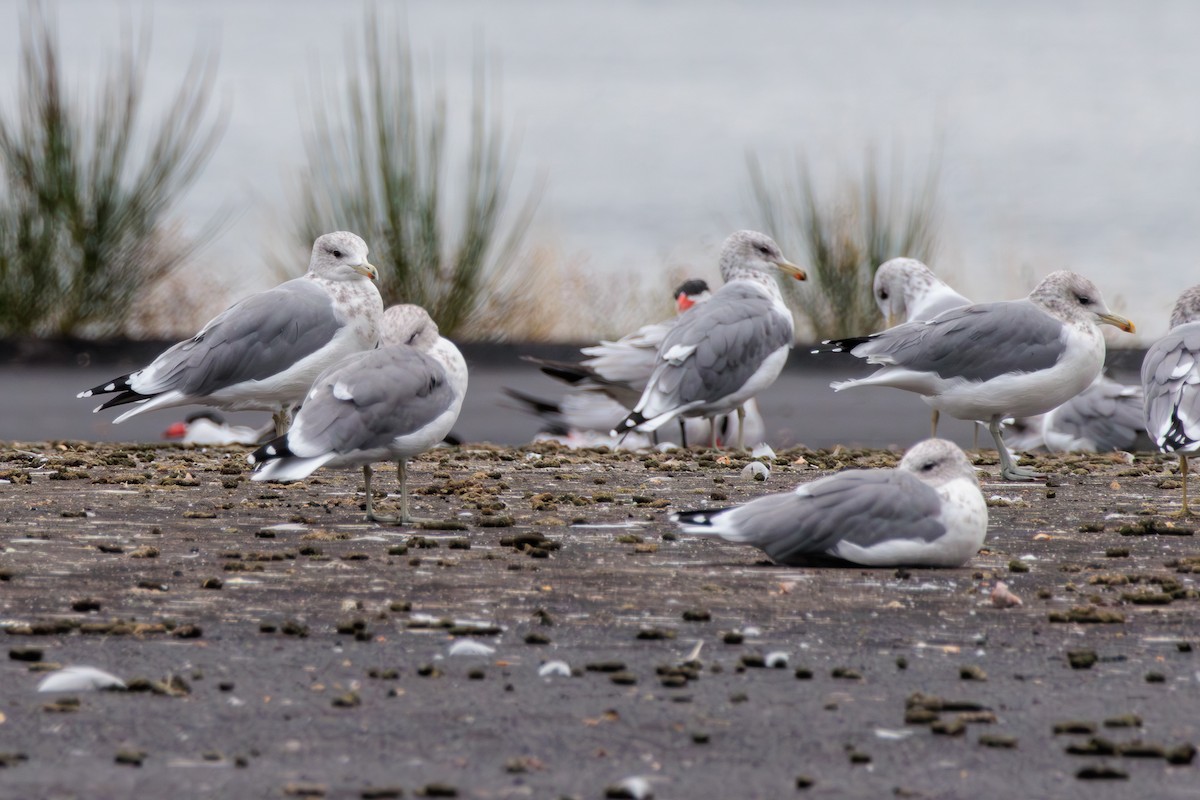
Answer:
[250, 306, 467, 524]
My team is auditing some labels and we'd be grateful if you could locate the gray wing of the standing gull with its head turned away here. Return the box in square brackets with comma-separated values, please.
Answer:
[288, 345, 455, 457]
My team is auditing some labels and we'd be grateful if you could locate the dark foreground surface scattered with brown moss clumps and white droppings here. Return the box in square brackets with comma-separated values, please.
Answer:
[0, 443, 1200, 799]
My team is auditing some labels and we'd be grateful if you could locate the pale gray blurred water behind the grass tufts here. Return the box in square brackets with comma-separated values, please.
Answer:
[0, 0, 1200, 342]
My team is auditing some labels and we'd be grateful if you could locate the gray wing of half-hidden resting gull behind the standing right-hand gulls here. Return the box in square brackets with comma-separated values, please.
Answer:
[1048, 378, 1146, 452]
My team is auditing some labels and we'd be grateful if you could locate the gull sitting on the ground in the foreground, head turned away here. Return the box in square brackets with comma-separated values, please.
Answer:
[671, 439, 988, 567]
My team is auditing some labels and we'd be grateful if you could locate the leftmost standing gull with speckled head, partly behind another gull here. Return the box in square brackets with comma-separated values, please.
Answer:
[79, 231, 383, 434]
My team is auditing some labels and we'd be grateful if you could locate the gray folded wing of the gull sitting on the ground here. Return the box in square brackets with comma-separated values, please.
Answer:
[730, 469, 946, 564]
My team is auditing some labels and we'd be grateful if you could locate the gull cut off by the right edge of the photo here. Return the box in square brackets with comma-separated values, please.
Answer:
[1141, 285, 1200, 517]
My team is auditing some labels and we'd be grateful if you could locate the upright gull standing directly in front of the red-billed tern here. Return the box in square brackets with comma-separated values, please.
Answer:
[613, 230, 805, 450]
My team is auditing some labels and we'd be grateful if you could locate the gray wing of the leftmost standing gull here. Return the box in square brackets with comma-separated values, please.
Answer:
[132, 278, 342, 397]
